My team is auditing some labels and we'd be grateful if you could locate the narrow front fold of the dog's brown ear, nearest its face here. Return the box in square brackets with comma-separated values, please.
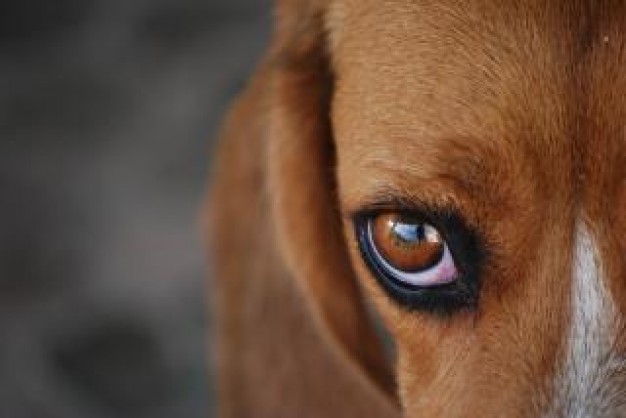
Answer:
[266, 0, 394, 397]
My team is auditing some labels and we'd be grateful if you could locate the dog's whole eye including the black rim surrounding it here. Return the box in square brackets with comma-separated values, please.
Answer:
[354, 205, 484, 315]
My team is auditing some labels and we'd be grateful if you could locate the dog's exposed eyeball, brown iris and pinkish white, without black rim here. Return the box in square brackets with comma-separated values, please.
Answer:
[367, 213, 456, 287]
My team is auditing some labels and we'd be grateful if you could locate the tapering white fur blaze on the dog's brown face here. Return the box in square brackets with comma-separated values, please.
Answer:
[547, 224, 626, 418]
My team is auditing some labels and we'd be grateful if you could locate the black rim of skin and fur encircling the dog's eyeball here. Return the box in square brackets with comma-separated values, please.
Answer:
[353, 206, 485, 316]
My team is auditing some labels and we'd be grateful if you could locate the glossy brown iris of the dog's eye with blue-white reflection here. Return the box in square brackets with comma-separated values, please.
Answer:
[371, 213, 445, 272]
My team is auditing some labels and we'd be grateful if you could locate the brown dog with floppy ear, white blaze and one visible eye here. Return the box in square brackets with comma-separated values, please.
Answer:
[207, 0, 626, 418]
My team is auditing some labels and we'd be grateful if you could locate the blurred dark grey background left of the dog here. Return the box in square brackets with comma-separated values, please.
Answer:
[0, 0, 271, 418]
